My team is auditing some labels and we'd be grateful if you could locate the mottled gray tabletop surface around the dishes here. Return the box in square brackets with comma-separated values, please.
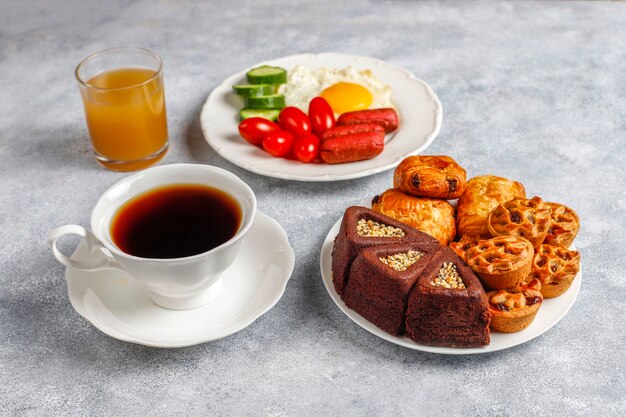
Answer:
[0, 0, 626, 416]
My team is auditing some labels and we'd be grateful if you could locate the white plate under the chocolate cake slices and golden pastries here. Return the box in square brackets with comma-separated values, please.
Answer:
[320, 214, 582, 355]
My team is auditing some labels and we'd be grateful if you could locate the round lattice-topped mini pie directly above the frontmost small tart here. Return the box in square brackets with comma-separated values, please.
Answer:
[465, 236, 535, 290]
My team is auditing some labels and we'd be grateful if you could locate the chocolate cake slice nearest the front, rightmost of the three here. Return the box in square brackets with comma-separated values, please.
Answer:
[406, 248, 491, 347]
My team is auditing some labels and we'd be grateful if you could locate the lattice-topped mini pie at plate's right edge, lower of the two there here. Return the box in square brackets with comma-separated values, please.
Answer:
[527, 244, 580, 298]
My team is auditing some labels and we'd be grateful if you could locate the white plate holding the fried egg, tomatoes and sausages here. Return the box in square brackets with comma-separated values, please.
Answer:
[200, 53, 443, 181]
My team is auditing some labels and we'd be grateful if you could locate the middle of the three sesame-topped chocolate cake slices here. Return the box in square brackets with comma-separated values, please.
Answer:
[343, 243, 443, 336]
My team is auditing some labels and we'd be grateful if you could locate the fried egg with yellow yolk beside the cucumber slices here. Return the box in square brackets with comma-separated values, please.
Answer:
[279, 65, 393, 115]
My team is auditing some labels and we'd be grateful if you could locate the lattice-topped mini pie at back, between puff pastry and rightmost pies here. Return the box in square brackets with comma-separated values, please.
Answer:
[487, 196, 552, 247]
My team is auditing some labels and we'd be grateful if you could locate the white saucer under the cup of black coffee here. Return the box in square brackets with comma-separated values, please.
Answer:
[66, 211, 294, 348]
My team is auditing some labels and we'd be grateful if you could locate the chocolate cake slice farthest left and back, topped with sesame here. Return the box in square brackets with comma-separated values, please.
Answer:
[332, 206, 438, 296]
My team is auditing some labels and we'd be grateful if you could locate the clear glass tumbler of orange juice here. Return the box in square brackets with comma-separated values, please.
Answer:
[76, 47, 168, 171]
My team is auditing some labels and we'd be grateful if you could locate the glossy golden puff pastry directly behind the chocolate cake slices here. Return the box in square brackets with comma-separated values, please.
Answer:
[372, 188, 456, 246]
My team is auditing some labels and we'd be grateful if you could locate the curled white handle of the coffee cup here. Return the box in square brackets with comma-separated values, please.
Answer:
[48, 224, 124, 271]
